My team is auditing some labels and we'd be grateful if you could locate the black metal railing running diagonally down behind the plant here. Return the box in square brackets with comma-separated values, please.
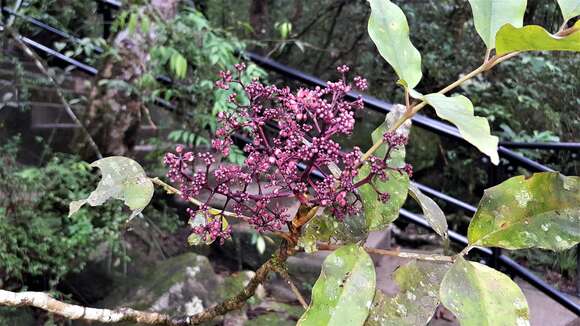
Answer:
[2, 0, 580, 316]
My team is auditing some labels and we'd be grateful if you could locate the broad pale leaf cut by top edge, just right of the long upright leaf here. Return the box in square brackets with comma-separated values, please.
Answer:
[469, 0, 527, 49]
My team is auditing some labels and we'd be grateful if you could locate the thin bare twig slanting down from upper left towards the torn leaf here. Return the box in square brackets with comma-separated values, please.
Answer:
[4, 26, 103, 159]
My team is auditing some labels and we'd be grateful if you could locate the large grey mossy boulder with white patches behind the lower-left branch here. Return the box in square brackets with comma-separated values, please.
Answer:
[99, 253, 265, 326]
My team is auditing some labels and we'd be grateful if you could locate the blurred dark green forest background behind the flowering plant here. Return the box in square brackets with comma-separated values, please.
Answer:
[0, 0, 580, 323]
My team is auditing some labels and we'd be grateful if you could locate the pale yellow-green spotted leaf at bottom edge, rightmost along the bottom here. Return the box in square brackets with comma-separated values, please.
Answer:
[439, 257, 530, 326]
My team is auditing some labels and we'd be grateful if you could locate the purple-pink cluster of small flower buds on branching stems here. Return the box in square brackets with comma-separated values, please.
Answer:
[164, 64, 410, 240]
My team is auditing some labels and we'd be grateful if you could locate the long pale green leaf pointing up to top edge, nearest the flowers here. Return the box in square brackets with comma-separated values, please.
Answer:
[368, 0, 422, 88]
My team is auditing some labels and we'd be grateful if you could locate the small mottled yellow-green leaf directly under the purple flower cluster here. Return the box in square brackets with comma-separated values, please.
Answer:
[298, 213, 368, 253]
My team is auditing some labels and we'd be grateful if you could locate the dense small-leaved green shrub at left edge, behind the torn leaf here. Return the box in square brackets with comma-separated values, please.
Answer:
[0, 142, 127, 287]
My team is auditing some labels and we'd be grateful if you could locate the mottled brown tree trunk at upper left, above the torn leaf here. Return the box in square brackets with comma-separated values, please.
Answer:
[75, 0, 179, 158]
